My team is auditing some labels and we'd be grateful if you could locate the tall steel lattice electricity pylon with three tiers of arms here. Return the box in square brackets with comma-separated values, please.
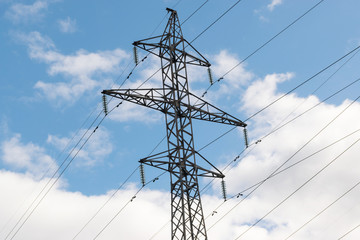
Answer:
[102, 9, 246, 240]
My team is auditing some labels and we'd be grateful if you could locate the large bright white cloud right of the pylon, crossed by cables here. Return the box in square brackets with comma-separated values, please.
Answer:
[210, 73, 360, 239]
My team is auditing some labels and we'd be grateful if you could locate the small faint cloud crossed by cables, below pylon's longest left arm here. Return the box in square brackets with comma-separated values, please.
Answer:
[47, 127, 113, 167]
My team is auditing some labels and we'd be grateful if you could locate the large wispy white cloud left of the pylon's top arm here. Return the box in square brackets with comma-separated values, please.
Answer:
[16, 32, 130, 102]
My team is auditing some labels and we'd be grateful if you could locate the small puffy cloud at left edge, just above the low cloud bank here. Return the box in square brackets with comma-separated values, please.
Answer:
[1, 134, 57, 177]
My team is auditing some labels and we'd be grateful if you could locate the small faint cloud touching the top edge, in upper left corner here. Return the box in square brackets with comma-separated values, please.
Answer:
[5, 1, 48, 23]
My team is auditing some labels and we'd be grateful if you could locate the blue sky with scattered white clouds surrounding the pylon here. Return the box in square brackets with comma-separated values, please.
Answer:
[0, 0, 360, 240]
